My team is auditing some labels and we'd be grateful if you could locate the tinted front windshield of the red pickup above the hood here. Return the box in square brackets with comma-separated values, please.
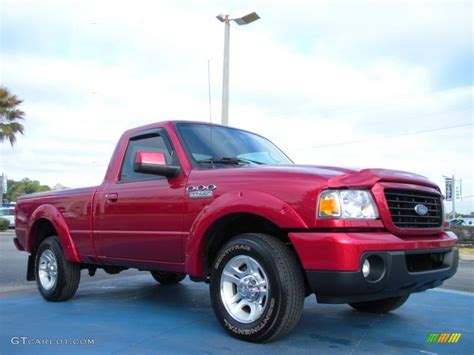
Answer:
[176, 123, 293, 166]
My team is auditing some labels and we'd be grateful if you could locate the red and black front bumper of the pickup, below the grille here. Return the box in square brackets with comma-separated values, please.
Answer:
[289, 232, 458, 303]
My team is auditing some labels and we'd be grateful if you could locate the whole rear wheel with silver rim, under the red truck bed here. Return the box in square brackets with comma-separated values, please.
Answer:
[35, 236, 81, 302]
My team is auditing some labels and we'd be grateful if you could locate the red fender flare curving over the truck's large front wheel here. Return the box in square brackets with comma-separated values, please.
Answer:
[186, 191, 308, 277]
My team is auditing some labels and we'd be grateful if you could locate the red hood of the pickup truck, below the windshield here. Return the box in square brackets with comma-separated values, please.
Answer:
[241, 165, 438, 189]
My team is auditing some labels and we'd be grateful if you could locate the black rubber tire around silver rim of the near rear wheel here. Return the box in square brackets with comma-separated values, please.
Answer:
[35, 236, 81, 302]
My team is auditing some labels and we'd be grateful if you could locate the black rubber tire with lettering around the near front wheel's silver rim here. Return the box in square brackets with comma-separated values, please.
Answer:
[210, 233, 305, 343]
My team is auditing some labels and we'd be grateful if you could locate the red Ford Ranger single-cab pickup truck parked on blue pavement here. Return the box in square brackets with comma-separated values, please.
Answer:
[14, 121, 458, 342]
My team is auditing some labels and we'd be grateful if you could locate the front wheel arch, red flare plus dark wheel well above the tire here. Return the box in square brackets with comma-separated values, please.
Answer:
[186, 191, 308, 277]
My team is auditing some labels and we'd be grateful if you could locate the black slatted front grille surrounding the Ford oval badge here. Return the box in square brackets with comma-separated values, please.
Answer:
[385, 189, 443, 228]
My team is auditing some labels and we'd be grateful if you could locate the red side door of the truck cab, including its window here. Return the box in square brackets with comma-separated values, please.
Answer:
[95, 129, 185, 263]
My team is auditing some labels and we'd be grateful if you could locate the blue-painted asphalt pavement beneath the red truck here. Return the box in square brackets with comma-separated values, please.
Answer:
[0, 232, 474, 354]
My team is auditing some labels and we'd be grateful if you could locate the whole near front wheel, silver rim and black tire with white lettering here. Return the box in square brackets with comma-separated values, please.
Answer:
[210, 234, 305, 342]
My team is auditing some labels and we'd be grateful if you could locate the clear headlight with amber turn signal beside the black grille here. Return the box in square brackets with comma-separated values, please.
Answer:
[318, 190, 379, 219]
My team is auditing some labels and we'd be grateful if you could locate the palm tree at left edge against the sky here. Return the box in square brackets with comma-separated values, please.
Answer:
[0, 87, 25, 147]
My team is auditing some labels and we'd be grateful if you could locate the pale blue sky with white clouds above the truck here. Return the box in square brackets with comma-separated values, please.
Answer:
[0, 0, 474, 212]
